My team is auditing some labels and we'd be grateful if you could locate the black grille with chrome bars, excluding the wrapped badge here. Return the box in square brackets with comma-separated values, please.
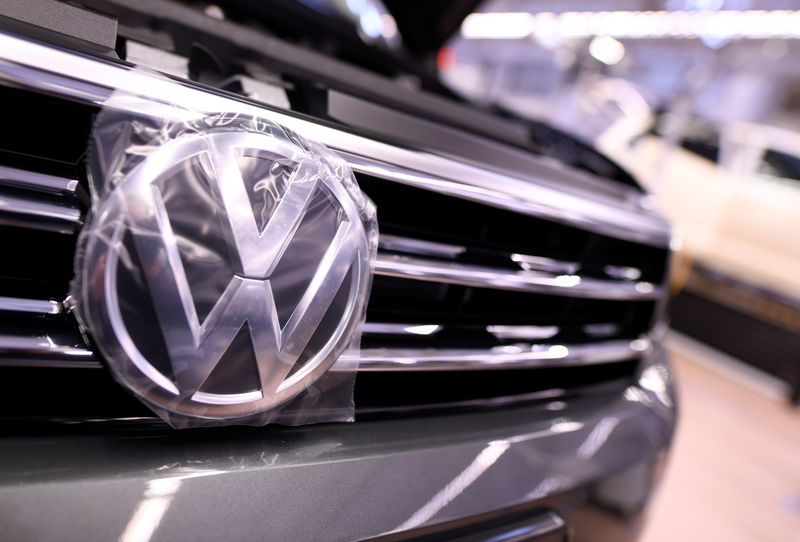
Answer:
[0, 31, 668, 428]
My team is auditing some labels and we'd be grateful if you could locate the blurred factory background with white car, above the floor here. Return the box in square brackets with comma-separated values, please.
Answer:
[437, 0, 800, 410]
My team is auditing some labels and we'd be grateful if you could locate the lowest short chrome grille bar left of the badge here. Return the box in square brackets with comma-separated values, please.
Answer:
[0, 335, 100, 368]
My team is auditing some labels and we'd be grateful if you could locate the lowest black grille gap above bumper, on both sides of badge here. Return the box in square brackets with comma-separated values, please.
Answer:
[0, 361, 638, 428]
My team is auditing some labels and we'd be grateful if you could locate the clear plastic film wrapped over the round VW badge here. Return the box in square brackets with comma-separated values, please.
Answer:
[72, 92, 377, 427]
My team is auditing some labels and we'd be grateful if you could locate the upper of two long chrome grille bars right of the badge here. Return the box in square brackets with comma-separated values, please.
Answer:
[375, 254, 661, 300]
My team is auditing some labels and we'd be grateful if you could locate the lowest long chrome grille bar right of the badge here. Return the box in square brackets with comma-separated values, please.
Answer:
[358, 339, 650, 371]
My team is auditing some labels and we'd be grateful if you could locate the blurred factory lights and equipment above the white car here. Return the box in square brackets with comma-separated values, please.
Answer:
[440, 0, 800, 139]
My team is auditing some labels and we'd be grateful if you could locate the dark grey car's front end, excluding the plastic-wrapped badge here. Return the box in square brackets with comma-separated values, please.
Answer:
[0, 0, 676, 541]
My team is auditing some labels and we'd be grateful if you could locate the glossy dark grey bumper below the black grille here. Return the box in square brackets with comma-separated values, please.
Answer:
[0, 352, 675, 540]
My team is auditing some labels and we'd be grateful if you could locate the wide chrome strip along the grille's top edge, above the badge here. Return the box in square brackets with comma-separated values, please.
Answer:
[0, 30, 670, 247]
